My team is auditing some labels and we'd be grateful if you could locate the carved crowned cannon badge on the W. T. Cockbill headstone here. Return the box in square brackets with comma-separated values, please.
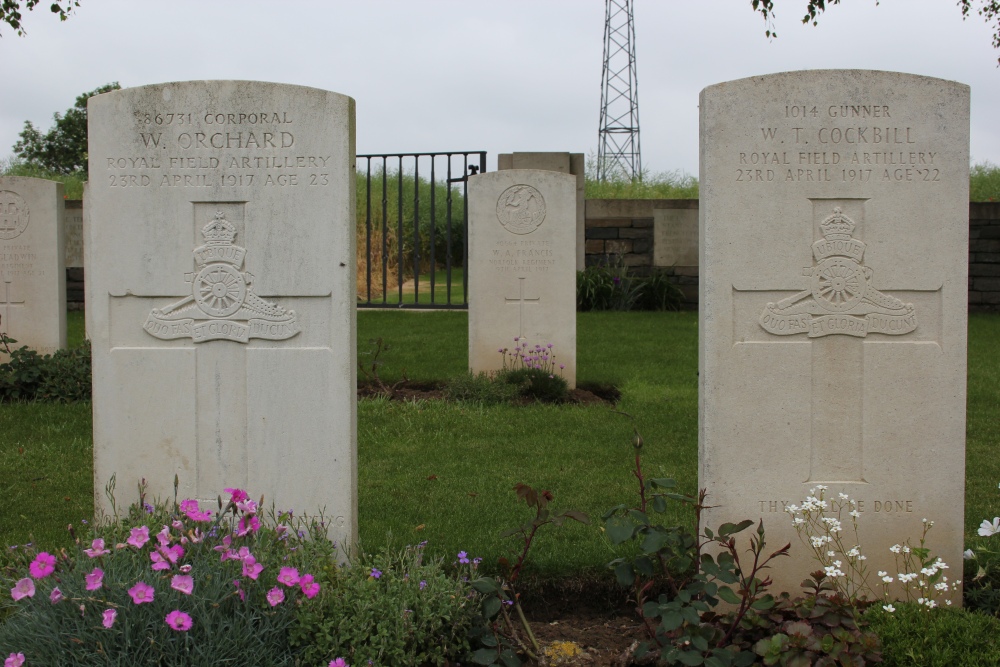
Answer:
[758, 207, 917, 338]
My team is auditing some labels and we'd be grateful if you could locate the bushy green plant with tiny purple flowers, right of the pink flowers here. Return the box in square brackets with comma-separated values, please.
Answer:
[291, 544, 478, 667]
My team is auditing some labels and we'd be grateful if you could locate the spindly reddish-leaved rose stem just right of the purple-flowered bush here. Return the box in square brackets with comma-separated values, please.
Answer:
[470, 484, 590, 667]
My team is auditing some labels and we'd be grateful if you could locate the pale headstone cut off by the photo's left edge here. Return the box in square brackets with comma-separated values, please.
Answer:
[0, 176, 66, 361]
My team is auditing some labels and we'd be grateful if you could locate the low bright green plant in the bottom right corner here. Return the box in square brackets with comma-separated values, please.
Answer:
[865, 603, 1000, 667]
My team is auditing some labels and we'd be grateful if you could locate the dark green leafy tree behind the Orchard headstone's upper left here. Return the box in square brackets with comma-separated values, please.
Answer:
[14, 81, 121, 174]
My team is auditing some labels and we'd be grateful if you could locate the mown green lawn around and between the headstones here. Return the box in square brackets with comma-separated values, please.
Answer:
[0, 311, 1000, 575]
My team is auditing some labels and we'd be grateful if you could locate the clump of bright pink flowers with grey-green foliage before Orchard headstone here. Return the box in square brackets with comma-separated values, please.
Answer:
[0, 487, 335, 667]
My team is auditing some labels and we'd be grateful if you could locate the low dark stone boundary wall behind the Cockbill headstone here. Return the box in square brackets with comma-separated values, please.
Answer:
[584, 199, 1000, 312]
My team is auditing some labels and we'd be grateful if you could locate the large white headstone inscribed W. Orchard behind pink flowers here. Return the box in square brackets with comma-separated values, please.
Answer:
[86, 81, 357, 544]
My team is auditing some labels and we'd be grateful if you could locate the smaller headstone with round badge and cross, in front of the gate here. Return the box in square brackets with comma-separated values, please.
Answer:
[468, 169, 576, 388]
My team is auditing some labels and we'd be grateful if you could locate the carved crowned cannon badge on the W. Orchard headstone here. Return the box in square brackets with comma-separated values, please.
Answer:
[143, 212, 300, 343]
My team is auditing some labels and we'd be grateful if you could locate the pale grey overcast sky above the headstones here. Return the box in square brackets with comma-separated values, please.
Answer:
[0, 0, 1000, 175]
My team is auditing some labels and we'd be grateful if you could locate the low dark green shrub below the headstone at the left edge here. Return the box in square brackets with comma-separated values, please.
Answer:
[0, 341, 91, 403]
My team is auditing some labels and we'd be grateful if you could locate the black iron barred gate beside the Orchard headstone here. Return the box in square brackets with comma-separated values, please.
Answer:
[357, 151, 486, 309]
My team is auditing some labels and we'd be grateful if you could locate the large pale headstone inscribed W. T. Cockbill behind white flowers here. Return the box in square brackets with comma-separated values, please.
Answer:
[699, 71, 969, 601]
